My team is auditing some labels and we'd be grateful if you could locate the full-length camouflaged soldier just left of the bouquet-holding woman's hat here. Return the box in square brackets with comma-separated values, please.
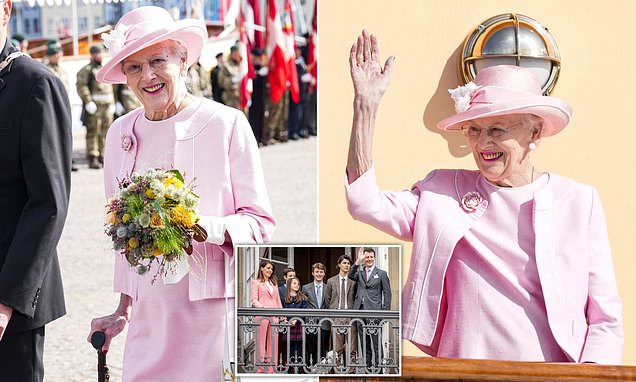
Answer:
[77, 44, 115, 169]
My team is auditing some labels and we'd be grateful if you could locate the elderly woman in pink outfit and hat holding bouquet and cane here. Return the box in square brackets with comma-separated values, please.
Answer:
[89, 7, 275, 382]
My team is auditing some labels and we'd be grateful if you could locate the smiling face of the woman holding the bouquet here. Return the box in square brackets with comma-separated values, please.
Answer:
[122, 40, 186, 119]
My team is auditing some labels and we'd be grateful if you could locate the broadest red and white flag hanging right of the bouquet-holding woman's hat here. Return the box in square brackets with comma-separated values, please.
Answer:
[266, 0, 300, 103]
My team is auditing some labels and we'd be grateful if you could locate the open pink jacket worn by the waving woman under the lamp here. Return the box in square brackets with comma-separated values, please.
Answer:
[345, 168, 623, 364]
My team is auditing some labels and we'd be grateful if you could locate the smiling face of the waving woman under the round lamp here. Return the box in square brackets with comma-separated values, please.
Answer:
[462, 114, 541, 187]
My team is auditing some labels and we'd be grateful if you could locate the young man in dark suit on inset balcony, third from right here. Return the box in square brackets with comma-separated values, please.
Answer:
[303, 263, 329, 364]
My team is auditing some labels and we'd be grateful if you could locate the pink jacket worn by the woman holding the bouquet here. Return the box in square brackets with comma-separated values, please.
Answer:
[104, 99, 276, 301]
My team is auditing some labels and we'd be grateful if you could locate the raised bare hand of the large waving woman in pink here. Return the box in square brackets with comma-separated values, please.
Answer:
[349, 29, 395, 103]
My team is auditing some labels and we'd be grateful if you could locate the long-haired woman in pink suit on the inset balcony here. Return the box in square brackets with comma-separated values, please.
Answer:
[252, 260, 283, 373]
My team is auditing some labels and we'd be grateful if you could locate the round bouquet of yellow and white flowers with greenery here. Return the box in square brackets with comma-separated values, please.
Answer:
[106, 169, 207, 281]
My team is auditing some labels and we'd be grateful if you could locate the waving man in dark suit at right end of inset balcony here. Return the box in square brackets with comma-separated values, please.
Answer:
[349, 248, 391, 367]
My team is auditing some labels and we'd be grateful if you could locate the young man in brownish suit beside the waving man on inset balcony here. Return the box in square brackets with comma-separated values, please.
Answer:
[325, 255, 358, 363]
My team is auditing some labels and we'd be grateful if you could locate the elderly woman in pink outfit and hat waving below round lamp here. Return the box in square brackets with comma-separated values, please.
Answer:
[346, 31, 623, 364]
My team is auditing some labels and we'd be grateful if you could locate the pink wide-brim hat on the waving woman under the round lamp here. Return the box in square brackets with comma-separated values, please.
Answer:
[437, 65, 572, 137]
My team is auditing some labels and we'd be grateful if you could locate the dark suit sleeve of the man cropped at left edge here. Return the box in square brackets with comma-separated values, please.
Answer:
[0, 75, 72, 317]
